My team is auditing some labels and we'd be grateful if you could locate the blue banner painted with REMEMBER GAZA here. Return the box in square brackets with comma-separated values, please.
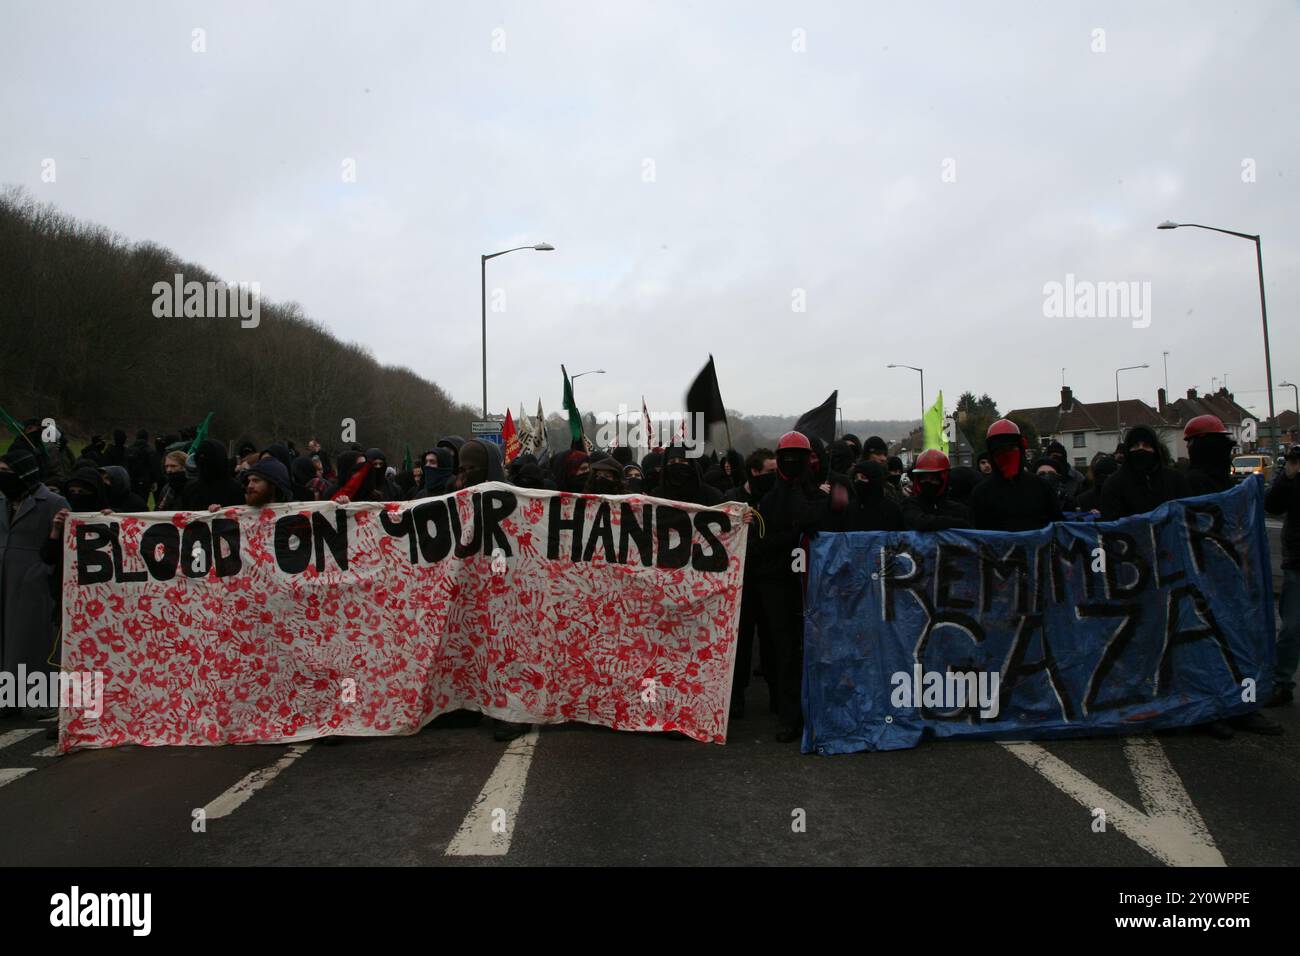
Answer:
[803, 481, 1277, 753]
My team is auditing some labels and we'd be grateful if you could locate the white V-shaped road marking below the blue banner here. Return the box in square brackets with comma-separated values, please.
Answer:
[1002, 737, 1227, 866]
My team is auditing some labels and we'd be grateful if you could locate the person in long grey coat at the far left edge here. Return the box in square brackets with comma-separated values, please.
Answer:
[0, 447, 68, 717]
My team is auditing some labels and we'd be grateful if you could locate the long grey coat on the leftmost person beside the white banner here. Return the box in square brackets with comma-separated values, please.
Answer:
[0, 485, 68, 674]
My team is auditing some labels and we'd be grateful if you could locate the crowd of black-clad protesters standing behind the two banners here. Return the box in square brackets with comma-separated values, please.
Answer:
[0, 415, 1300, 741]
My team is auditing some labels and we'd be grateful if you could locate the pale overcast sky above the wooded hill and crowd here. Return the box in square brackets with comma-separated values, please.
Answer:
[0, 0, 1300, 419]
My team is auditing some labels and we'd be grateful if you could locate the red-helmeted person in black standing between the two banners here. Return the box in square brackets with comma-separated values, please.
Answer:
[755, 432, 826, 743]
